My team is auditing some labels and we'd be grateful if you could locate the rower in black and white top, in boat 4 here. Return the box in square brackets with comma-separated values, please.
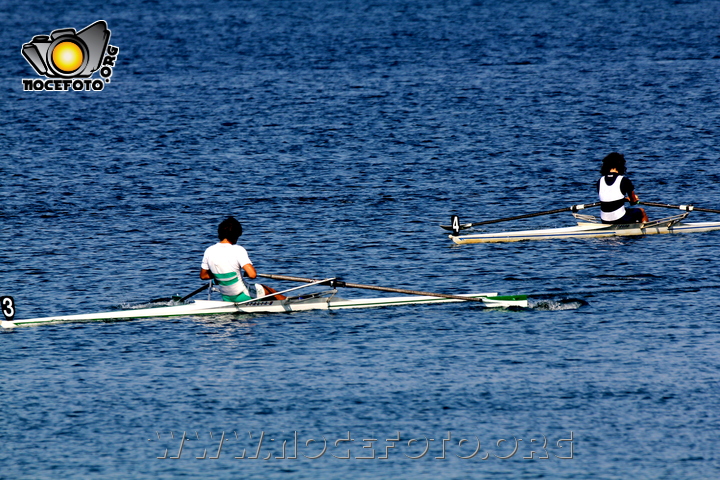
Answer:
[597, 152, 648, 223]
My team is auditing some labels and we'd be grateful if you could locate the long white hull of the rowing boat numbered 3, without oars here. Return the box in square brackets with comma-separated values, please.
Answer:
[1, 293, 528, 328]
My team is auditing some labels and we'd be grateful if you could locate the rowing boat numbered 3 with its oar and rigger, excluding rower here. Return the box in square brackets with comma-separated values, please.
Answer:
[1, 275, 528, 329]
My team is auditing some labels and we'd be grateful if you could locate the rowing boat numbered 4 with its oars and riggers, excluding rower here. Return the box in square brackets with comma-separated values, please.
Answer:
[443, 202, 720, 245]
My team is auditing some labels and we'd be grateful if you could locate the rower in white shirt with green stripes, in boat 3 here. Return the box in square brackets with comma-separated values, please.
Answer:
[200, 217, 285, 302]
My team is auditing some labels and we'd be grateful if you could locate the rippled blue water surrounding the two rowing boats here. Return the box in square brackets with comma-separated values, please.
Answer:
[0, 0, 720, 479]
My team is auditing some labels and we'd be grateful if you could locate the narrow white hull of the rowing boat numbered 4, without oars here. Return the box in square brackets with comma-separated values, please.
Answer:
[449, 222, 720, 245]
